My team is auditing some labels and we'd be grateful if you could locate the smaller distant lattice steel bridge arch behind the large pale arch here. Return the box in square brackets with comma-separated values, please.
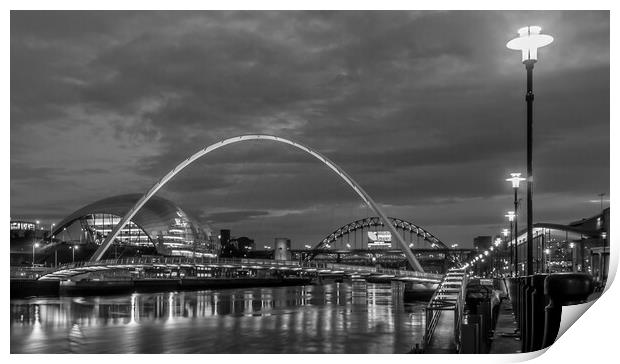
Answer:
[314, 216, 449, 250]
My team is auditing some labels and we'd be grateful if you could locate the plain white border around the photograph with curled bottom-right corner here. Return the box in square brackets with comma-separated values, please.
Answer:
[0, 0, 620, 364]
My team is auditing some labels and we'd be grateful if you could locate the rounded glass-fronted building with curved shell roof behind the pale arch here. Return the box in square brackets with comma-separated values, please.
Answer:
[48, 194, 219, 257]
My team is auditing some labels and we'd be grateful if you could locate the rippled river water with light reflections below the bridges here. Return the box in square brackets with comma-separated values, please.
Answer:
[11, 282, 424, 353]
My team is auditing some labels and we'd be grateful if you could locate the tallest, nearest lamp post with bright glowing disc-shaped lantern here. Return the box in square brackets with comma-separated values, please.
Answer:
[506, 25, 553, 275]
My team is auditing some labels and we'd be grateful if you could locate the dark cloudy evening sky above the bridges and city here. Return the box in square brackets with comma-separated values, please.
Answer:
[10, 11, 610, 247]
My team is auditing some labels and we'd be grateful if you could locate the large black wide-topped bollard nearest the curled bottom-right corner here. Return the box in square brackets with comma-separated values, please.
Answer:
[543, 272, 594, 348]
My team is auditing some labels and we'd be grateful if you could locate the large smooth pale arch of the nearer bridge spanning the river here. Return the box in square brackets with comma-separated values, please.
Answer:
[90, 134, 424, 272]
